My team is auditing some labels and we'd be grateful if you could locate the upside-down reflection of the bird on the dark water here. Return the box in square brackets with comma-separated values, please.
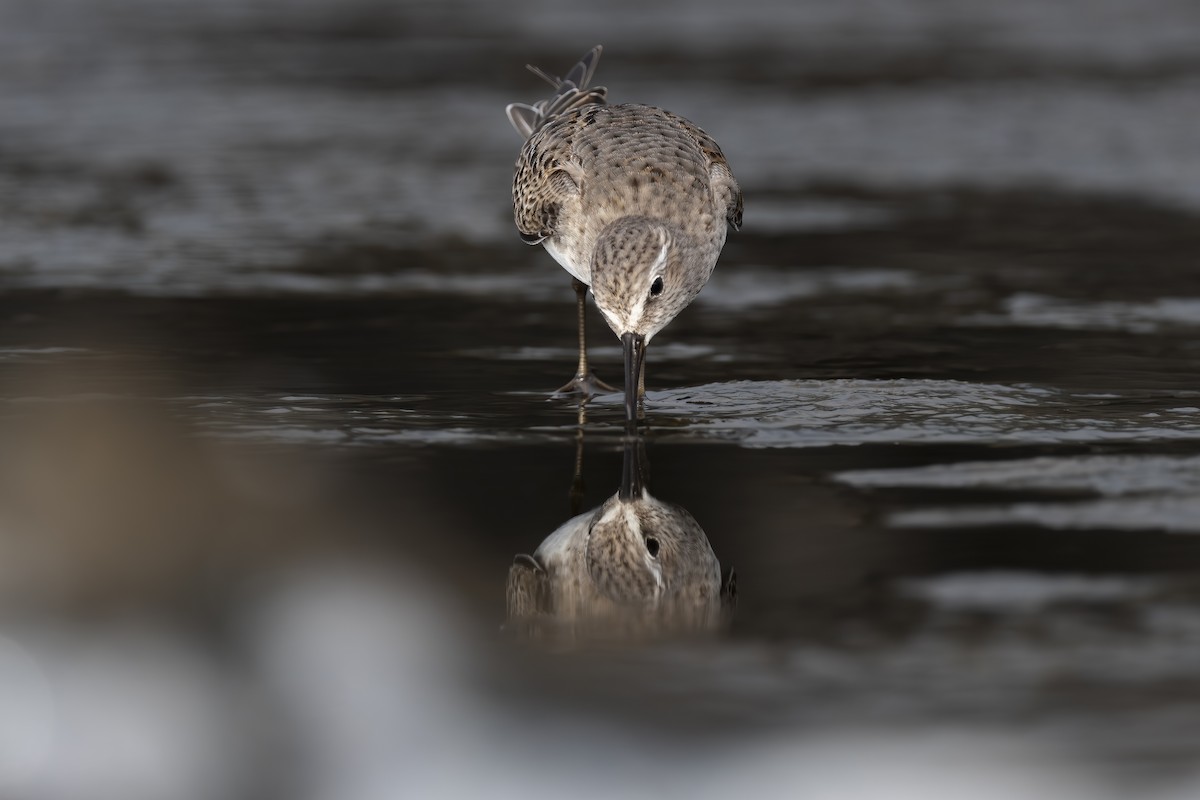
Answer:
[508, 429, 736, 638]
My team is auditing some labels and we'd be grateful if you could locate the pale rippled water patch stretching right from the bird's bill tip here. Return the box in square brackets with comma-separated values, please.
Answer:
[604, 379, 1200, 447]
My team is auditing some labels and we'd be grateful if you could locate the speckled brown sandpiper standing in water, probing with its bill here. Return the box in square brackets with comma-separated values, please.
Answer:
[508, 47, 742, 423]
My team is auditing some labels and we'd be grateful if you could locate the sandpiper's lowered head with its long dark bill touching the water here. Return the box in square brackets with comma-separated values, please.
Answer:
[592, 216, 712, 421]
